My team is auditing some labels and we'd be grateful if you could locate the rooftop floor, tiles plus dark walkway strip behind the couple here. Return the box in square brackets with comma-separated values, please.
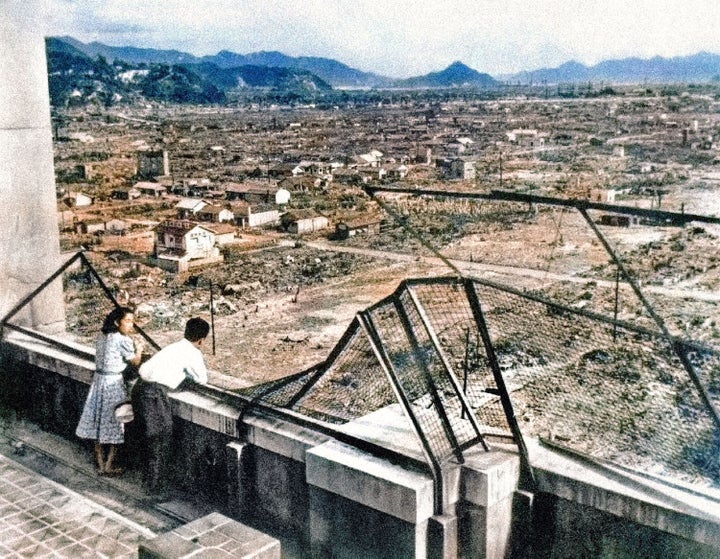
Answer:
[0, 410, 219, 559]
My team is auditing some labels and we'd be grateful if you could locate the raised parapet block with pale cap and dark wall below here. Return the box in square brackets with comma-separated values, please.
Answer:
[305, 441, 434, 559]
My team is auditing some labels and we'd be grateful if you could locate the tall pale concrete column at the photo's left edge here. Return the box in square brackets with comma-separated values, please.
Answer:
[0, 5, 65, 332]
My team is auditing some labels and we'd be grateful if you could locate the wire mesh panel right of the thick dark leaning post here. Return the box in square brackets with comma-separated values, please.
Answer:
[474, 282, 720, 483]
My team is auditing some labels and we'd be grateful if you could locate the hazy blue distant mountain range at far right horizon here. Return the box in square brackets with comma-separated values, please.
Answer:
[502, 52, 720, 84]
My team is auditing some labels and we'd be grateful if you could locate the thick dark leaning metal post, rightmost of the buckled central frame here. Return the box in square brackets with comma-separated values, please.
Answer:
[465, 279, 536, 488]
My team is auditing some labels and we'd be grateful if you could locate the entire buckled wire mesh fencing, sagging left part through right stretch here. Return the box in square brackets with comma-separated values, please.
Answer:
[246, 278, 720, 485]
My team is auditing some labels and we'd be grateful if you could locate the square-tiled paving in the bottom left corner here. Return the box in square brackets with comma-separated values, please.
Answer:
[0, 455, 154, 559]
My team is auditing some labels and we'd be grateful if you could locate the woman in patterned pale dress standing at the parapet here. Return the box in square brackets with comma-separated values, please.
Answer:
[75, 307, 143, 475]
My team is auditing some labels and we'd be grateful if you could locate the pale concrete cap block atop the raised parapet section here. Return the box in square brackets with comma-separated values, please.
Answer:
[306, 441, 434, 524]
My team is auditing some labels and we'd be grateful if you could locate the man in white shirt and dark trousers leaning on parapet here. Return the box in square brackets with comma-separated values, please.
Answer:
[133, 318, 210, 492]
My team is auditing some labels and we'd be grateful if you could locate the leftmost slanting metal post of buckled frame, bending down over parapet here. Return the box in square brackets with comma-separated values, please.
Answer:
[358, 311, 443, 514]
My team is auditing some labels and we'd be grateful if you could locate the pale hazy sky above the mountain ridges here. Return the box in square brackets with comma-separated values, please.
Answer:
[9, 0, 720, 77]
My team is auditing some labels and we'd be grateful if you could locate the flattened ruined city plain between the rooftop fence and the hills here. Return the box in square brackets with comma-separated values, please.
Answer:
[53, 86, 720, 394]
